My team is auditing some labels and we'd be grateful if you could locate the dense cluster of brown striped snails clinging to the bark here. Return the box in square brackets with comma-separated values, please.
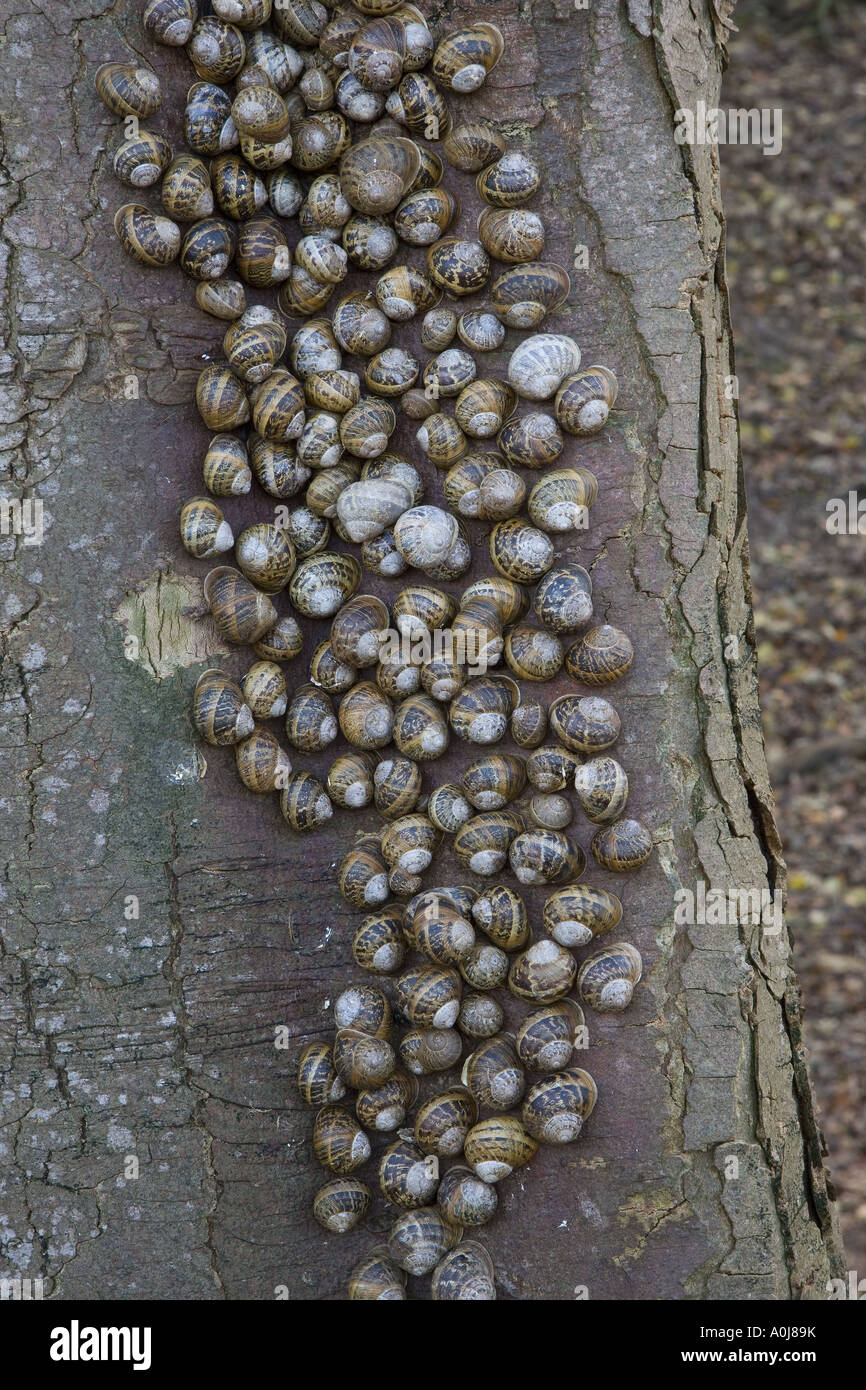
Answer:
[104, 0, 652, 1300]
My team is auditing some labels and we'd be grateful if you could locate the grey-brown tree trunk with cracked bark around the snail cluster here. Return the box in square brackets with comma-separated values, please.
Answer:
[0, 0, 842, 1300]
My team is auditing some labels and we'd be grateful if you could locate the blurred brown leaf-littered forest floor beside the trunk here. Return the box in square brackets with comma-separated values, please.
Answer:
[720, 0, 866, 1276]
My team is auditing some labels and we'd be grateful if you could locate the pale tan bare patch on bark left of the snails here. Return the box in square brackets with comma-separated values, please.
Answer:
[113, 570, 228, 681]
